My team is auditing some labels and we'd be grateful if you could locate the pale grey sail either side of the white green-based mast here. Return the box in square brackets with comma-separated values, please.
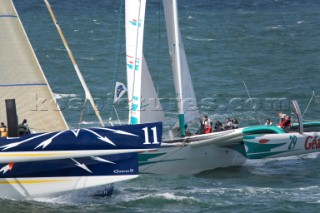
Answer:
[163, 0, 200, 123]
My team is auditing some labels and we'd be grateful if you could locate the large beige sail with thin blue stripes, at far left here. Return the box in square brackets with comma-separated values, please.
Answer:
[0, 0, 68, 132]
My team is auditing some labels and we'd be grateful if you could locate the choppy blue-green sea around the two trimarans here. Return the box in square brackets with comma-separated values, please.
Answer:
[4, 0, 320, 212]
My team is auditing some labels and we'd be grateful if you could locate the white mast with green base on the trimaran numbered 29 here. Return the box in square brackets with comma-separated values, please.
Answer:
[172, 0, 185, 136]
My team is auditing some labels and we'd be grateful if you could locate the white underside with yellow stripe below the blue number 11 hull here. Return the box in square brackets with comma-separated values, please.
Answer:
[0, 175, 138, 199]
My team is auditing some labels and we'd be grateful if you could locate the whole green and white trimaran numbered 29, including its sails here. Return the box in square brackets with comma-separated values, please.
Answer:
[126, 0, 320, 174]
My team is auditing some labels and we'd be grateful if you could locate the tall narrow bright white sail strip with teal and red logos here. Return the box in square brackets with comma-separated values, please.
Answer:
[126, 0, 146, 124]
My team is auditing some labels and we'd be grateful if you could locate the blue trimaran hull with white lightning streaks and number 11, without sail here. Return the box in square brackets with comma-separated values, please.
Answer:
[0, 122, 162, 198]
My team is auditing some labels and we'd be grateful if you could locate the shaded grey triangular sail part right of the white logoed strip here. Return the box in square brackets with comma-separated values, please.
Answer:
[140, 57, 165, 123]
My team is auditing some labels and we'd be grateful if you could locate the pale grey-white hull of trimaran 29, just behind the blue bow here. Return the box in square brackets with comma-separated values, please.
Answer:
[139, 131, 247, 175]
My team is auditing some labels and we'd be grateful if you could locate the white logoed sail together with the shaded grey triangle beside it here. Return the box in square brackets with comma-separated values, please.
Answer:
[126, 0, 164, 124]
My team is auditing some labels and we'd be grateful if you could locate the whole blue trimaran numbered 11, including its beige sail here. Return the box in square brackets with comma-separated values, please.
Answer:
[0, 0, 162, 199]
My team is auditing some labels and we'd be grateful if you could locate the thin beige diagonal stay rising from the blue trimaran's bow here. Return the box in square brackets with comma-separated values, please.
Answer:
[44, 0, 104, 126]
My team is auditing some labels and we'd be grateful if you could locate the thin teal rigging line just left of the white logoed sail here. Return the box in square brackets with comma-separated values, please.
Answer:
[109, 0, 124, 117]
